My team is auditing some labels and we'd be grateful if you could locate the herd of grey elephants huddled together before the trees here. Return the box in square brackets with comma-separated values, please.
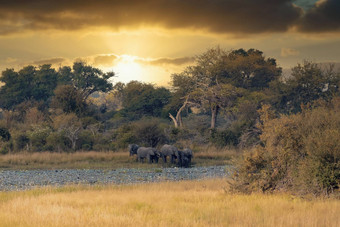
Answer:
[128, 144, 193, 168]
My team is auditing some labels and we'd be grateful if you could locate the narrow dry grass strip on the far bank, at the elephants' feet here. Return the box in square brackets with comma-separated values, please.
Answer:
[0, 150, 235, 169]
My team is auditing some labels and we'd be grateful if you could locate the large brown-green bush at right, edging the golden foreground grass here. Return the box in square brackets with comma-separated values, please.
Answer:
[233, 98, 340, 195]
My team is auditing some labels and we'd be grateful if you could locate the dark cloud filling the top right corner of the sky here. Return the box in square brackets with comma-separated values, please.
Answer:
[298, 0, 340, 32]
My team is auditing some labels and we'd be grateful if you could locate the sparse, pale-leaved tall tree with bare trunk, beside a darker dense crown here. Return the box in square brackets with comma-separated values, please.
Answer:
[173, 47, 252, 129]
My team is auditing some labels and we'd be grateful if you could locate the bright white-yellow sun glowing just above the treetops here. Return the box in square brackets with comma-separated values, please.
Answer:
[113, 55, 144, 82]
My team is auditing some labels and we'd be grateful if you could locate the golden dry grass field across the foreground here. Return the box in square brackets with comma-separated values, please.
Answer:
[0, 179, 340, 227]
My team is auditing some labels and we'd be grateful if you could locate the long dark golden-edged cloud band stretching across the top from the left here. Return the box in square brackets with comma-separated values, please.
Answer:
[0, 0, 302, 34]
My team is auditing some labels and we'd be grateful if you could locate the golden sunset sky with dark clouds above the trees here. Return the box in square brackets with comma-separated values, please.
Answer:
[0, 0, 340, 86]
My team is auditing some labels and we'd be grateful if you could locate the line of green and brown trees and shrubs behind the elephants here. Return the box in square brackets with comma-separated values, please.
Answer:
[0, 47, 340, 153]
